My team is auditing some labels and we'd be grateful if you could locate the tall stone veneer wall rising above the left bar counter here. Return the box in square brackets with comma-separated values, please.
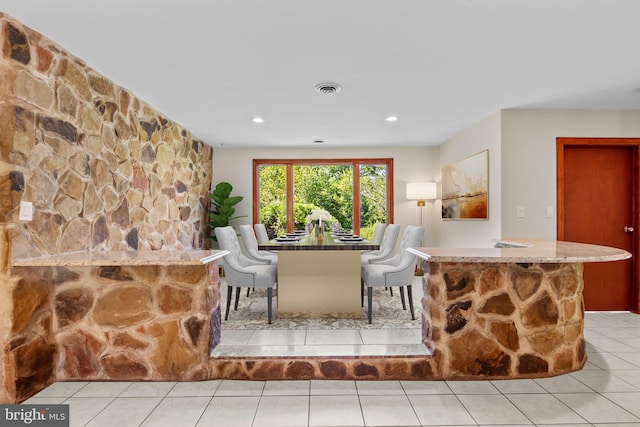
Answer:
[0, 13, 212, 401]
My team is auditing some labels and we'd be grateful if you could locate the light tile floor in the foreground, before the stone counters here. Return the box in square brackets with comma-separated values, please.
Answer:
[25, 313, 640, 427]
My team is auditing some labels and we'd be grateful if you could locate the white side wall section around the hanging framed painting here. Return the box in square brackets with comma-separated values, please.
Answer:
[438, 113, 502, 248]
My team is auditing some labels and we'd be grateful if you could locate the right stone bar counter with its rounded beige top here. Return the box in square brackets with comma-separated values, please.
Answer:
[410, 240, 631, 379]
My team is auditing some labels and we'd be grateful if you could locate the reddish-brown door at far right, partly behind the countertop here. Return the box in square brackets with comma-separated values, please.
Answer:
[558, 139, 640, 311]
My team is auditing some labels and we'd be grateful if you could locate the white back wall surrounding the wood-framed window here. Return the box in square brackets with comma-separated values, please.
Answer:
[213, 147, 440, 246]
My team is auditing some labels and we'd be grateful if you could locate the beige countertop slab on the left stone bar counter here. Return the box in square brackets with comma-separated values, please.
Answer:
[12, 249, 229, 267]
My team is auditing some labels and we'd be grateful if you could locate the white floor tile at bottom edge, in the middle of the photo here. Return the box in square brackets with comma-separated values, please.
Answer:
[309, 395, 364, 427]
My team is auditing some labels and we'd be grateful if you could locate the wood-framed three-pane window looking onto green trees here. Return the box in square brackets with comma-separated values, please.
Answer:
[253, 159, 393, 237]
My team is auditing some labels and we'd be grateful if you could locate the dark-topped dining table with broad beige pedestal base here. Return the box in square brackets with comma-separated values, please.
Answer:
[258, 231, 380, 319]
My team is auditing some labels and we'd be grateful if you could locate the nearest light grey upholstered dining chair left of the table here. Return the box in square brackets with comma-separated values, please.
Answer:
[214, 226, 278, 323]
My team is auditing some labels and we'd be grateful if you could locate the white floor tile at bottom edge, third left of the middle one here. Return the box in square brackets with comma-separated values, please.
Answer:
[141, 396, 211, 427]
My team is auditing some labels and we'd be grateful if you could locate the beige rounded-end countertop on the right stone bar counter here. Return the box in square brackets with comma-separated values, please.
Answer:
[409, 239, 631, 263]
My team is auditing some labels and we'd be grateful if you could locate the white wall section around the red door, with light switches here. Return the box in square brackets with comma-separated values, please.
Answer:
[502, 110, 640, 240]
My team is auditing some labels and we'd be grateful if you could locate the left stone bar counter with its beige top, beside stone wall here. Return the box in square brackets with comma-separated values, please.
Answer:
[5, 250, 228, 401]
